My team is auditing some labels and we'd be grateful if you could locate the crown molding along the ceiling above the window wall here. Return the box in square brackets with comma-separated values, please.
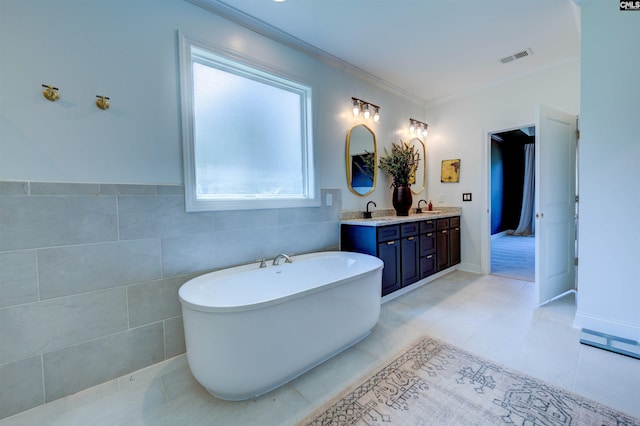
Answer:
[186, 0, 426, 106]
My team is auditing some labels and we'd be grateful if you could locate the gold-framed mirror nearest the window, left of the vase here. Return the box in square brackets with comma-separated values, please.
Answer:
[345, 124, 378, 197]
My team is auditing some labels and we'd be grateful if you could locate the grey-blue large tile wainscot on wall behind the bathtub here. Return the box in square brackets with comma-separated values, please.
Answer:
[0, 181, 341, 418]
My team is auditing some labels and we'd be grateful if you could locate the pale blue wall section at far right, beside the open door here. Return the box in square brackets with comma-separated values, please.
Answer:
[576, 0, 640, 341]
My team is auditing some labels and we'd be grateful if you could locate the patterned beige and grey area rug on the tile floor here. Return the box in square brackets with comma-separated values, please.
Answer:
[299, 337, 640, 426]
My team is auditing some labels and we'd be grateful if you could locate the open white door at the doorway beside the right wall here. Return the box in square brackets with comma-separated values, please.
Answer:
[535, 106, 577, 304]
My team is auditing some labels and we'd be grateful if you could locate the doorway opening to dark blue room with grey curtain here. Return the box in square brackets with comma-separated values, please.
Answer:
[489, 126, 536, 282]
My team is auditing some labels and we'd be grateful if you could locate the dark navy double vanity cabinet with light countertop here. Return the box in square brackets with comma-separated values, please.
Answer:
[340, 214, 460, 296]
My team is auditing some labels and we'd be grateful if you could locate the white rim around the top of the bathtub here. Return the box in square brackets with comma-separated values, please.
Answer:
[178, 251, 384, 313]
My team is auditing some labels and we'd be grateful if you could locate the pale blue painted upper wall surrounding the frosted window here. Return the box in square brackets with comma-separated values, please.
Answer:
[0, 0, 424, 210]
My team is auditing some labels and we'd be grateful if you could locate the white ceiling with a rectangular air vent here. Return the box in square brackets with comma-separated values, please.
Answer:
[188, 0, 580, 104]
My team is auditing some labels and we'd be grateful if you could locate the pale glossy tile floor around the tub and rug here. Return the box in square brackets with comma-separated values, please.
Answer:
[0, 271, 640, 426]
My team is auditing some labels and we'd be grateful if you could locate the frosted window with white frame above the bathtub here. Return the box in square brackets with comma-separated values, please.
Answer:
[180, 34, 320, 211]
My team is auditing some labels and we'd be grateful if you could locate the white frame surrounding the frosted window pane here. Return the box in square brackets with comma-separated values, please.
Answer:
[178, 33, 321, 211]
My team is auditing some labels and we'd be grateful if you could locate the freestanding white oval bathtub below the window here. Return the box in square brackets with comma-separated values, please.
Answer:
[179, 252, 383, 401]
